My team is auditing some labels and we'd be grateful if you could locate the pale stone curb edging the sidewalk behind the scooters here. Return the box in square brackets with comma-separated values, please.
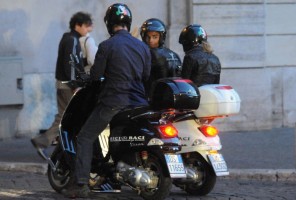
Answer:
[0, 162, 296, 182]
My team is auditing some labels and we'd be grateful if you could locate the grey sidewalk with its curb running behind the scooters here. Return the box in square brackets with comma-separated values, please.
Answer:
[0, 128, 296, 180]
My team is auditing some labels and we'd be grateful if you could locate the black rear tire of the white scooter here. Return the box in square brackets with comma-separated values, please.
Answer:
[184, 154, 216, 196]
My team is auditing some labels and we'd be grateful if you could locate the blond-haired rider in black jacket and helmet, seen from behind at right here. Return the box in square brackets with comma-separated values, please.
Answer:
[179, 24, 221, 87]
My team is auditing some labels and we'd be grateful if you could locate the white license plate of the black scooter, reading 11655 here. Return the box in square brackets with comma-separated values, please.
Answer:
[165, 154, 186, 178]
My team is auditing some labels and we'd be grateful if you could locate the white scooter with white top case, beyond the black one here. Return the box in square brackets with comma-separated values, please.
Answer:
[173, 84, 241, 196]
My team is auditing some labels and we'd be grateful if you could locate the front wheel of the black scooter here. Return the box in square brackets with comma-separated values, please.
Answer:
[47, 144, 73, 193]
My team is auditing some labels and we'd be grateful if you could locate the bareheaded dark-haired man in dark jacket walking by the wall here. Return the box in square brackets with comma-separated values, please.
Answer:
[31, 12, 92, 159]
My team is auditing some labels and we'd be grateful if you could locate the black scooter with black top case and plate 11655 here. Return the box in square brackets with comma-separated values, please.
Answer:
[47, 54, 199, 200]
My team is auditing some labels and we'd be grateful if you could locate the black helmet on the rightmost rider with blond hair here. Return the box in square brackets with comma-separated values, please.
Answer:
[179, 24, 207, 51]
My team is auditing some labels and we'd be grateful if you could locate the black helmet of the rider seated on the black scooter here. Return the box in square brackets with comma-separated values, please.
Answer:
[104, 3, 132, 35]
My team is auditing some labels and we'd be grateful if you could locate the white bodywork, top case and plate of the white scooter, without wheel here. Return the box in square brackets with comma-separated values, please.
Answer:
[174, 84, 241, 176]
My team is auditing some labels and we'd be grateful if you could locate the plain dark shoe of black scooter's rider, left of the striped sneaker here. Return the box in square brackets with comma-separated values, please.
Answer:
[62, 185, 90, 199]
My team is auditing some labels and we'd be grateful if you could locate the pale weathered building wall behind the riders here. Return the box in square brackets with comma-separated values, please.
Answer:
[0, 0, 296, 136]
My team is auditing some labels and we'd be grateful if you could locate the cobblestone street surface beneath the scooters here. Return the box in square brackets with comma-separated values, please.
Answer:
[0, 171, 296, 200]
